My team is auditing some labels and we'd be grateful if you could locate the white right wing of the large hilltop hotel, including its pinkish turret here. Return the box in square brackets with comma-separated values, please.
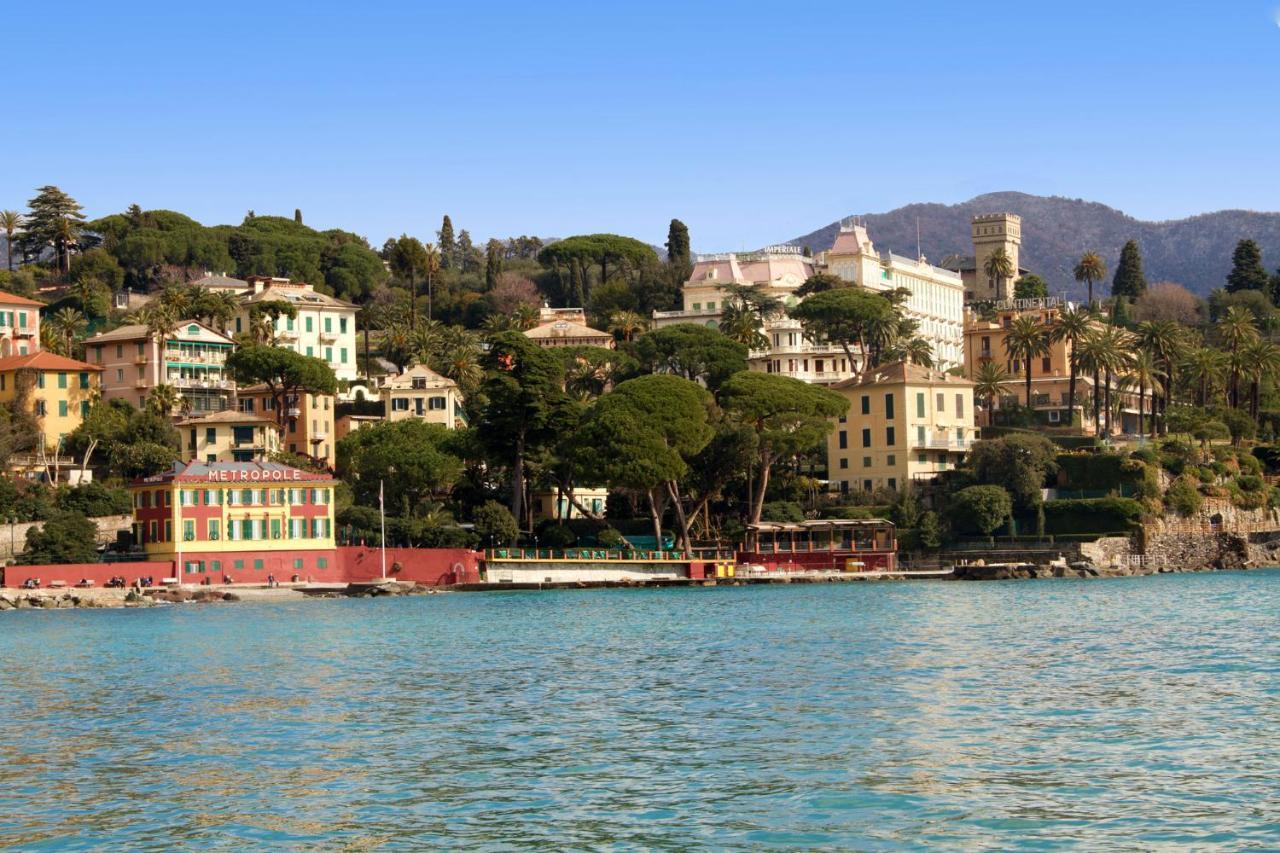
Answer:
[818, 224, 964, 370]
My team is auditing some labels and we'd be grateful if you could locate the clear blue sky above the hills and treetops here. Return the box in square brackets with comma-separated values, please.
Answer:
[0, 0, 1280, 251]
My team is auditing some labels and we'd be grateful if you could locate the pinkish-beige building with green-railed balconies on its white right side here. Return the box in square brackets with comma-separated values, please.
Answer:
[84, 320, 236, 414]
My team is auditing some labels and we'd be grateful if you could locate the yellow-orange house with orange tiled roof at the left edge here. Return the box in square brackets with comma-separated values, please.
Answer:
[0, 352, 102, 451]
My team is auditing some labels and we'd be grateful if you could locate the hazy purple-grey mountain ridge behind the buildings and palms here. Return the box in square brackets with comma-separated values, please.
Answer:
[786, 192, 1280, 296]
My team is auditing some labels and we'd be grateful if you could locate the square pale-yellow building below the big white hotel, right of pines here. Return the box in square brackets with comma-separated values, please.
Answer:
[827, 361, 977, 492]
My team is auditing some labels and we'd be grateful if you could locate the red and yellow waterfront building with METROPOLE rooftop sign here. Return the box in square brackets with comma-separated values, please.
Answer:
[131, 462, 335, 583]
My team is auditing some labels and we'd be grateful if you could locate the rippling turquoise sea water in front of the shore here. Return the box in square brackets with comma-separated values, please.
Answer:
[0, 570, 1280, 850]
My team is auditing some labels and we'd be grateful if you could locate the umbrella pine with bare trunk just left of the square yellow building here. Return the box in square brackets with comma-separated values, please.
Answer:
[719, 368, 849, 523]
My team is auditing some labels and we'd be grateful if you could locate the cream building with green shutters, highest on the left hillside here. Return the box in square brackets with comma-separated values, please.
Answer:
[230, 275, 358, 380]
